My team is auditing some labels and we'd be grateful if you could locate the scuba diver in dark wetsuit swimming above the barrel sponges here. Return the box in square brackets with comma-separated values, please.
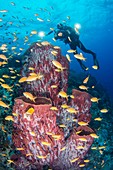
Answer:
[46, 23, 99, 70]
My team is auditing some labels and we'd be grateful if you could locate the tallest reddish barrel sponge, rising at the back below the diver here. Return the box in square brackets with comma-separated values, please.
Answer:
[21, 43, 69, 105]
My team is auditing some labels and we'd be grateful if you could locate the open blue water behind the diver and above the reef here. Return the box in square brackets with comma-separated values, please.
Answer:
[0, 0, 113, 99]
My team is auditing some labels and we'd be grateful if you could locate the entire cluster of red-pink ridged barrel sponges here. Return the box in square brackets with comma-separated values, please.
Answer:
[13, 43, 93, 170]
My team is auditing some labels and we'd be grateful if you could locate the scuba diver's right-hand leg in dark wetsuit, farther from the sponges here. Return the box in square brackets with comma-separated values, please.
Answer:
[78, 40, 99, 69]
